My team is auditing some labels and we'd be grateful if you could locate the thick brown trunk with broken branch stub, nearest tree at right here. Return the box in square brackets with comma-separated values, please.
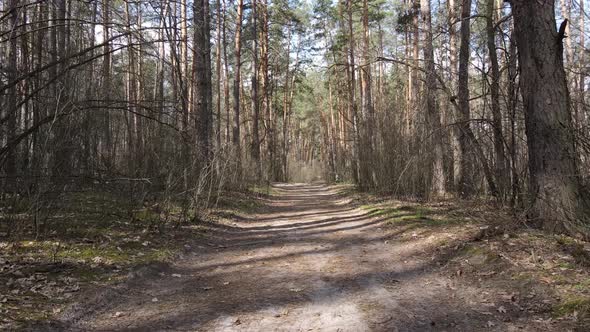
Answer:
[512, 0, 588, 231]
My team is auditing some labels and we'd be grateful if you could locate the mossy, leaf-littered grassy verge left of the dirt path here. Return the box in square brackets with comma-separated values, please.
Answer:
[0, 191, 259, 330]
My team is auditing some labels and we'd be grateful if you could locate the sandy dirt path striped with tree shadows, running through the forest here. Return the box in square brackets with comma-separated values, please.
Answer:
[57, 184, 544, 331]
